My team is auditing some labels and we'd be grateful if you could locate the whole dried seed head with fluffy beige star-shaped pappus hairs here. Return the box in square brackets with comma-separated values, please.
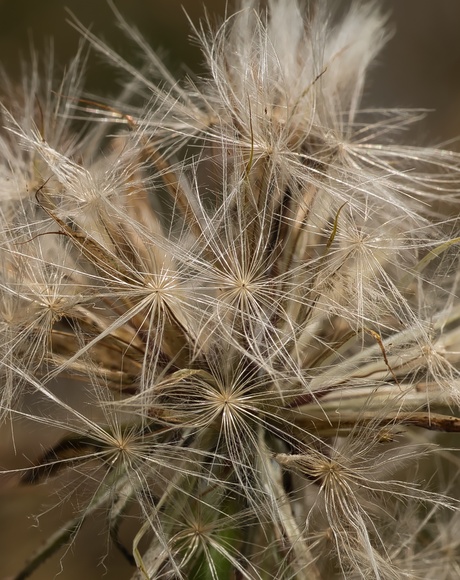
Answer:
[0, 0, 460, 580]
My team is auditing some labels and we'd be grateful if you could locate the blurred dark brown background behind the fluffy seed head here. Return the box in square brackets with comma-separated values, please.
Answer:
[0, 0, 460, 580]
